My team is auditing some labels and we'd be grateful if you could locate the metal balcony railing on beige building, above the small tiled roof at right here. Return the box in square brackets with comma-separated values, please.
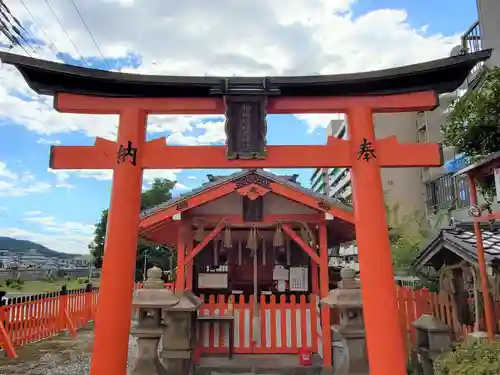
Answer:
[425, 173, 470, 214]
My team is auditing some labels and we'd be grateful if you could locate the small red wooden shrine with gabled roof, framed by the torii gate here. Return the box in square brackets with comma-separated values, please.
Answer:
[140, 169, 355, 362]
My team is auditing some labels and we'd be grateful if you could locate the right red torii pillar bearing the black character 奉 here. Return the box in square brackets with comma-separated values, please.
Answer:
[347, 106, 407, 375]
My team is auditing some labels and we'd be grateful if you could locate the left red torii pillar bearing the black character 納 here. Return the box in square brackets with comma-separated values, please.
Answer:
[90, 107, 147, 375]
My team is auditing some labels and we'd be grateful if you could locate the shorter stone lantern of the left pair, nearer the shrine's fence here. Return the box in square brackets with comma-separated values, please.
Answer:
[160, 291, 202, 374]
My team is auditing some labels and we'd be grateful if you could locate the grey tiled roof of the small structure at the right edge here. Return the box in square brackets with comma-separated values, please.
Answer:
[414, 221, 500, 268]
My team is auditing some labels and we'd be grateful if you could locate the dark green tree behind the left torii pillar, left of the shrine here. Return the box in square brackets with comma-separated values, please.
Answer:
[89, 178, 175, 278]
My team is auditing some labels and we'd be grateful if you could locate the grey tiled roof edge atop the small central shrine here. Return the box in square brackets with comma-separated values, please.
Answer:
[141, 169, 352, 219]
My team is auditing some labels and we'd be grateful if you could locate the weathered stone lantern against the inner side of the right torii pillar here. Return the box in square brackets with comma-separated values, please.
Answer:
[320, 268, 369, 375]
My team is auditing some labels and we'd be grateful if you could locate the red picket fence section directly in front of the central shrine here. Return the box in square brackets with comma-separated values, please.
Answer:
[198, 295, 319, 353]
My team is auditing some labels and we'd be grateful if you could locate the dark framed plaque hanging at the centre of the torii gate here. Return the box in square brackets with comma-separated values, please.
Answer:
[224, 95, 267, 160]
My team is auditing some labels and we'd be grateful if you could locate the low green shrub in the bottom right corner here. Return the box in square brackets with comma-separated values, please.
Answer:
[434, 339, 500, 375]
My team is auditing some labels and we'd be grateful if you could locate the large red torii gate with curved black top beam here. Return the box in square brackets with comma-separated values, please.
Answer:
[0, 51, 491, 375]
